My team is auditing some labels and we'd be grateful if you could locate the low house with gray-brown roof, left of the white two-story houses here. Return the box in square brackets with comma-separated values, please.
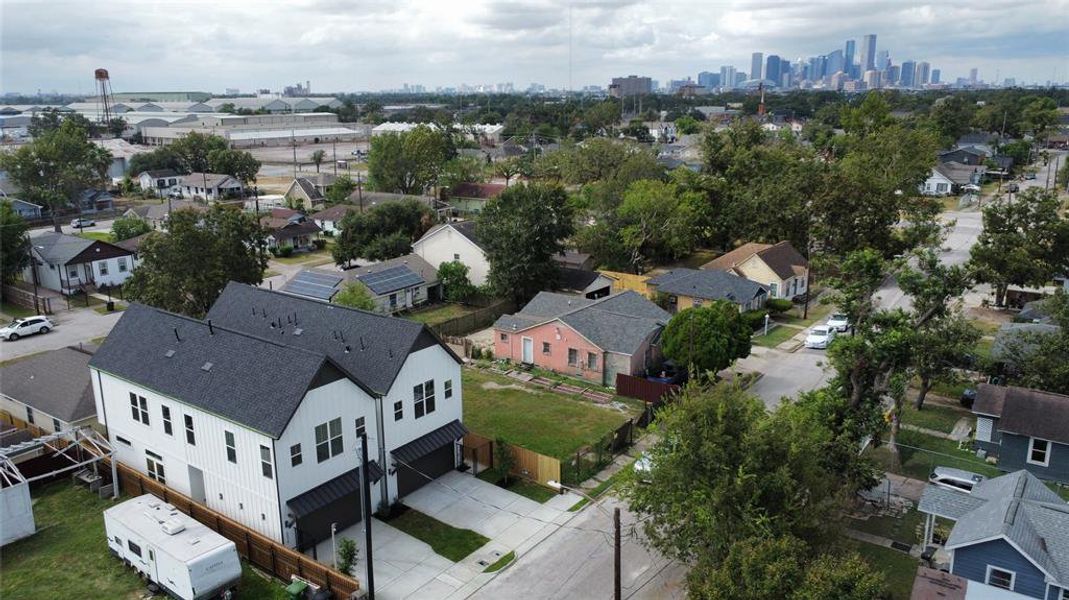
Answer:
[0, 347, 96, 432]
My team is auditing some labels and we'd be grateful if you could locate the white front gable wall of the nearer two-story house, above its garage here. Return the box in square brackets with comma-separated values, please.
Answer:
[273, 379, 378, 547]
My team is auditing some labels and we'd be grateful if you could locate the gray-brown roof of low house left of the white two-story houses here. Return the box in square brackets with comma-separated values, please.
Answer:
[0, 348, 96, 422]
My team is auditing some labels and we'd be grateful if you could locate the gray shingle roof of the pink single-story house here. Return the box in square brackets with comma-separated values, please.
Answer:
[494, 291, 671, 354]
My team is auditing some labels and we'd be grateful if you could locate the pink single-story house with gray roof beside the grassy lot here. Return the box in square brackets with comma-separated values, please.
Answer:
[494, 291, 671, 386]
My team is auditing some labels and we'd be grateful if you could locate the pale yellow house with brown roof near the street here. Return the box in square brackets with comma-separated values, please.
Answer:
[701, 242, 809, 298]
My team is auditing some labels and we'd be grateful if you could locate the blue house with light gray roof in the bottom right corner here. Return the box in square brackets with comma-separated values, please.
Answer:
[917, 471, 1069, 600]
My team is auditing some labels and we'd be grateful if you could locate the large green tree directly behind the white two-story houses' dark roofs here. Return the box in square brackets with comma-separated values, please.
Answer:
[124, 204, 267, 318]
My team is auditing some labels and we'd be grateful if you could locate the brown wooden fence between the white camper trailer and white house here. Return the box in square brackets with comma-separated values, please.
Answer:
[118, 463, 360, 598]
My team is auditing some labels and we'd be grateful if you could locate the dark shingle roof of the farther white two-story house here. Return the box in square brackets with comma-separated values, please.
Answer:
[207, 281, 460, 395]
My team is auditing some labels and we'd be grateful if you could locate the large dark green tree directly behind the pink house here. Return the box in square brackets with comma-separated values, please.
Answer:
[476, 184, 575, 302]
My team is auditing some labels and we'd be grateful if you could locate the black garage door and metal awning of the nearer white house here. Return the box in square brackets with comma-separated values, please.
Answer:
[285, 461, 384, 552]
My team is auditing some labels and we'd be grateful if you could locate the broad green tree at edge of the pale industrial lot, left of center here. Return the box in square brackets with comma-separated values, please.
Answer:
[368, 125, 452, 194]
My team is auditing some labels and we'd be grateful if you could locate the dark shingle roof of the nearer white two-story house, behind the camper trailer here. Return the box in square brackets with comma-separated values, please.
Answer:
[89, 304, 335, 437]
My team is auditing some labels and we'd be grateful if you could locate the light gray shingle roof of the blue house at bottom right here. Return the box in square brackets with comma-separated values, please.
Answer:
[919, 471, 1069, 586]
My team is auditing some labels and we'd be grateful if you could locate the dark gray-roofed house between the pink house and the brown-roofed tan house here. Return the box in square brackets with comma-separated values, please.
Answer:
[646, 268, 769, 312]
